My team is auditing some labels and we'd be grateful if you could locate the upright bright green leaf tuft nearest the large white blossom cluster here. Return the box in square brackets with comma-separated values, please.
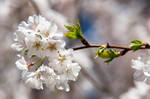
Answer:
[64, 21, 83, 40]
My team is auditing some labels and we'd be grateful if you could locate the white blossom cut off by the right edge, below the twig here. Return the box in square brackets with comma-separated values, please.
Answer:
[132, 57, 150, 84]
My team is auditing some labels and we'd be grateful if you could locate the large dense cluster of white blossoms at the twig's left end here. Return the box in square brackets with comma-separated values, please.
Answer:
[12, 15, 81, 92]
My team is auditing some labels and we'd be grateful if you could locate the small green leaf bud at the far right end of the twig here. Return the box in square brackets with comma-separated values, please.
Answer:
[130, 40, 144, 51]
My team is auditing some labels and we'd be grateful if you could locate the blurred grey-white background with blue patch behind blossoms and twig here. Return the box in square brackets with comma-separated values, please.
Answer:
[0, 0, 150, 99]
